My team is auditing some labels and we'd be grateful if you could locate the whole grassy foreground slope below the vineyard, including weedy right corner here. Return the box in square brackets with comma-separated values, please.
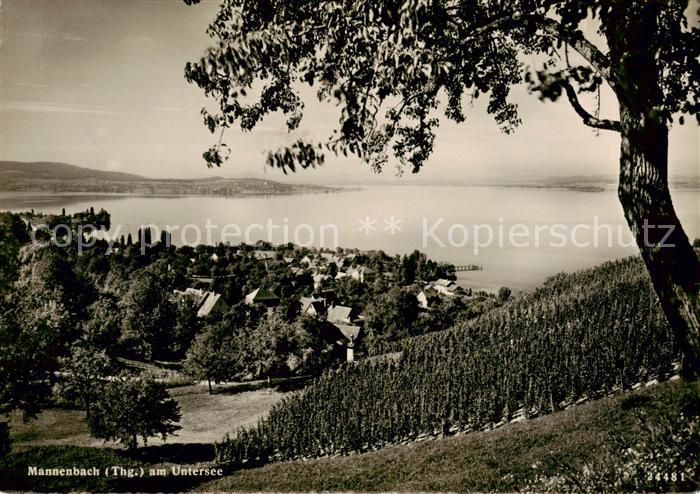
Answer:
[196, 382, 700, 492]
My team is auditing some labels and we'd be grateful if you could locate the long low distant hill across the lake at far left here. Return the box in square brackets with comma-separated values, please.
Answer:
[0, 161, 339, 196]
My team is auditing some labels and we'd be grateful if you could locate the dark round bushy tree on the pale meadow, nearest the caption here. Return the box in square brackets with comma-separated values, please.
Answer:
[88, 378, 180, 449]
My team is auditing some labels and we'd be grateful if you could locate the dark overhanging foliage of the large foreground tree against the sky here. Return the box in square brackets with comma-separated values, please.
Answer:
[185, 0, 700, 172]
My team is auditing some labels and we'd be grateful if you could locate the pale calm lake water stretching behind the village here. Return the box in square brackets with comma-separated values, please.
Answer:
[0, 186, 700, 291]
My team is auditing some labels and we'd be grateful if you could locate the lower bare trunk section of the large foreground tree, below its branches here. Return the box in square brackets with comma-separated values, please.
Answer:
[618, 105, 700, 379]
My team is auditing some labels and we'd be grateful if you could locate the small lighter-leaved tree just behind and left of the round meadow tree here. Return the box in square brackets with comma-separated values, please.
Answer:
[59, 344, 112, 417]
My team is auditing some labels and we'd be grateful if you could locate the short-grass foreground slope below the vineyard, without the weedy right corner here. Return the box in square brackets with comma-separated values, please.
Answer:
[197, 381, 700, 492]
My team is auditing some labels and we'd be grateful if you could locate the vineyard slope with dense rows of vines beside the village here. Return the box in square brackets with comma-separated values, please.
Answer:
[217, 258, 678, 466]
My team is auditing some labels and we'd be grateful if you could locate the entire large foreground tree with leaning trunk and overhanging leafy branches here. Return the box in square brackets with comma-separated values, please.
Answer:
[185, 0, 700, 377]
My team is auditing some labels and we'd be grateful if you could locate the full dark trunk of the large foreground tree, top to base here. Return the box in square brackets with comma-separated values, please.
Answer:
[605, 0, 700, 379]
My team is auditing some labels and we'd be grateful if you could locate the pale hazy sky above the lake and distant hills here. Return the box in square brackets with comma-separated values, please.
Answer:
[0, 0, 700, 181]
